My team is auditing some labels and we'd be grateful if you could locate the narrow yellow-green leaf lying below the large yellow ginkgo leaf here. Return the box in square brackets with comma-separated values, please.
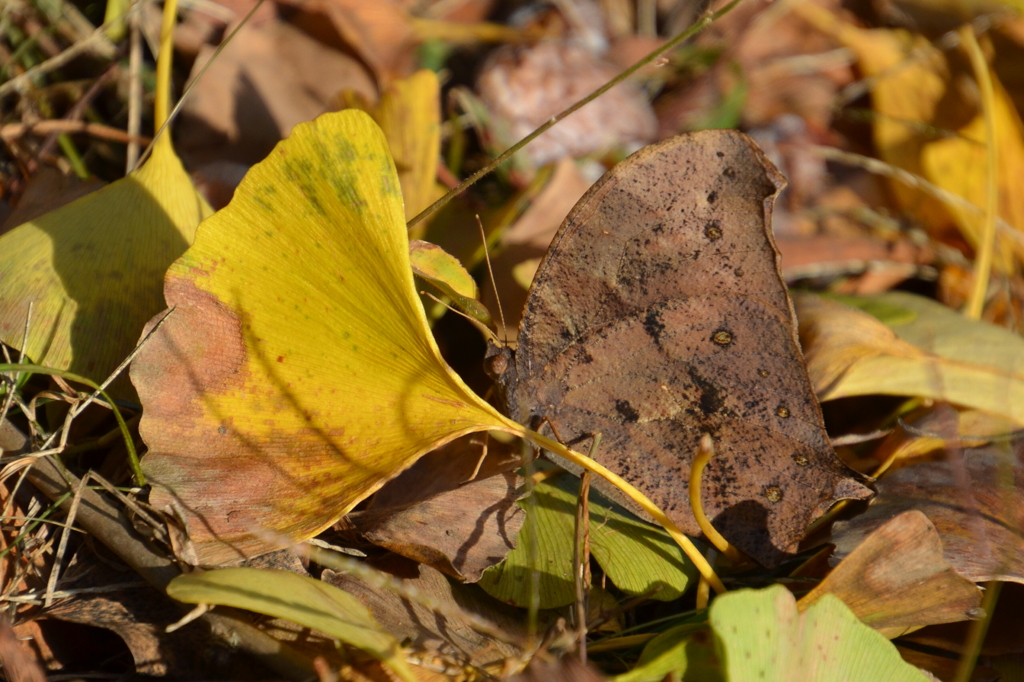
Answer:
[167, 568, 418, 682]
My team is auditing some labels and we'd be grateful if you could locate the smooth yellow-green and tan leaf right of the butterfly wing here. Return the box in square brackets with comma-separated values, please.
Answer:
[795, 292, 1024, 424]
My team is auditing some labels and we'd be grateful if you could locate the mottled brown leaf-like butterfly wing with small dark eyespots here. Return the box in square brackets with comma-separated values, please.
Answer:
[507, 130, 870, 565]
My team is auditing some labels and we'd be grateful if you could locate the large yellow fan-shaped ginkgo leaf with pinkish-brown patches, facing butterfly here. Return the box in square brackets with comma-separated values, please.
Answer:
[131, 111, 521, 564]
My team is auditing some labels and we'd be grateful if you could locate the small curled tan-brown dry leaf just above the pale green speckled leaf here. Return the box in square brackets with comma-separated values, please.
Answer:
[798, 511, 981, 638]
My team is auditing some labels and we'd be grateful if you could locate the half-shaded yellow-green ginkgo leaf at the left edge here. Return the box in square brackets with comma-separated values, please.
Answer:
[0, 135, 212, 395]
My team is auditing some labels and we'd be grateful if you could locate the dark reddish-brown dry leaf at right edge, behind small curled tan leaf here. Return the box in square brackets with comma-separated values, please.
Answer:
[833, 440, 1024, 583]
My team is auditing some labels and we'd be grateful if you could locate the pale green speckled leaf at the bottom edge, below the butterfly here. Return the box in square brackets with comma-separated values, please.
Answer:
[709, 585, 928, 682]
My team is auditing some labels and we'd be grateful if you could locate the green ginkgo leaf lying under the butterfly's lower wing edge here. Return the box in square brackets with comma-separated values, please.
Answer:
[479, 474, 696, 608]
